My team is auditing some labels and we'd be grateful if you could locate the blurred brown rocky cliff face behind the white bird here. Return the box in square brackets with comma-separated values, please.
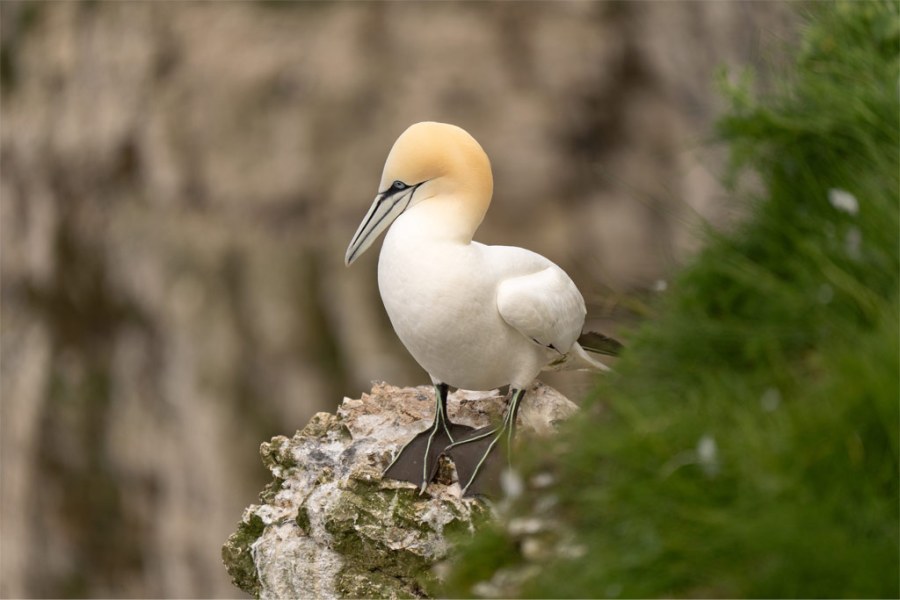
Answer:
[0, 2, 791, 597]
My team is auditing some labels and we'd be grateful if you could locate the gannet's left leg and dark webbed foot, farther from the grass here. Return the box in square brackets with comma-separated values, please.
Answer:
[382, 383, 472, 494]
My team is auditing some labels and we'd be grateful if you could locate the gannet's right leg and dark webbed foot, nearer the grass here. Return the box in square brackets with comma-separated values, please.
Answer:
[444, 389, 525, 496]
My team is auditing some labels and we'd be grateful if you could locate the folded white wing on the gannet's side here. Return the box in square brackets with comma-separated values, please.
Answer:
[497, 261, 586, 354]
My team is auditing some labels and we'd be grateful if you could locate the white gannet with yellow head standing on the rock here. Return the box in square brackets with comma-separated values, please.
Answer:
[345, 122, 620, 495]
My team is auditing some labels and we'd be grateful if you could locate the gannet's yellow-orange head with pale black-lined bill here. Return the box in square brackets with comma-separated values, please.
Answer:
[344, 121, 494, 265]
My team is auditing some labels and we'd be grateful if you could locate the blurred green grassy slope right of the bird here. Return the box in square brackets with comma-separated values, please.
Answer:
[448, 2, 900, 598]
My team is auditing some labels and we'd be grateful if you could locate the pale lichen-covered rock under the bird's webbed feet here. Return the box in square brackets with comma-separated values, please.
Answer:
[222, 383, 576, 598]
